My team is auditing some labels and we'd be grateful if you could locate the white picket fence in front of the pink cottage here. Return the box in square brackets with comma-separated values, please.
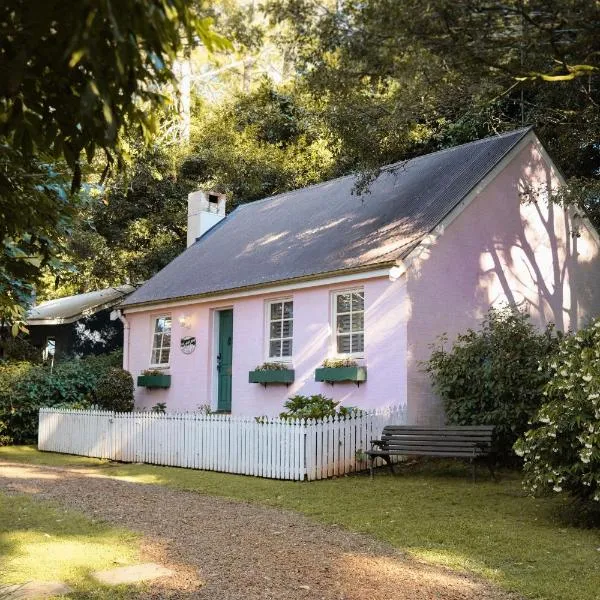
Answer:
[38, 407, 406, 481]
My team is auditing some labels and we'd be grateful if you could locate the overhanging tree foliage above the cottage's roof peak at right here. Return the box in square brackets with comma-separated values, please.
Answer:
[267, 0, 600, 218]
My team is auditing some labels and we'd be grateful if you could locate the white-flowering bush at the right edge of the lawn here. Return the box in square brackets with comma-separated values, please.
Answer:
[515, 319, 600, 502]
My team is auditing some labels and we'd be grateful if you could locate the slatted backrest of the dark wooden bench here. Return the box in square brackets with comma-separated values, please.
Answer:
[381, 425, 494, 456]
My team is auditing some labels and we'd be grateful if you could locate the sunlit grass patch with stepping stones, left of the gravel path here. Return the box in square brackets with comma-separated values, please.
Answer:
[0, 494, 139, 600]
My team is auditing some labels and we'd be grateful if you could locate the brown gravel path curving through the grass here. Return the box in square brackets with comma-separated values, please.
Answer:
[0, 462, 515, 600]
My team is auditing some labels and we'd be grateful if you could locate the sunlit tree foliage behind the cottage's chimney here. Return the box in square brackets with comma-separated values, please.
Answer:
[39, 79, 335, 298]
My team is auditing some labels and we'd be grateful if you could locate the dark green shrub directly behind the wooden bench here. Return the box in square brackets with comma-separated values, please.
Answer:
[424, 307, 560, 462]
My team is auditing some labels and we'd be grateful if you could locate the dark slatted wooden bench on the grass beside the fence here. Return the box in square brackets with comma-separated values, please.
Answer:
[366, 425, 495, 479]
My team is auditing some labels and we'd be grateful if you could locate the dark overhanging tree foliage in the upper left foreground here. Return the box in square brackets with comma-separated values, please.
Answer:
[0, 0, 227, 320]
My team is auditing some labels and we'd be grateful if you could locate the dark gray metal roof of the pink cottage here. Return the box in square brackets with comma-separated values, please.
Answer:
[123, 128, 530, 306]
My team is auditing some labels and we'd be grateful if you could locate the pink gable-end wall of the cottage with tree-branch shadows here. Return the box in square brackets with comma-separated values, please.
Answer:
[407, 142, 600, 422]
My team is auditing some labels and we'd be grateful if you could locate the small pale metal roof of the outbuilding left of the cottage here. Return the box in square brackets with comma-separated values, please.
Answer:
[27, 285, 135, 325]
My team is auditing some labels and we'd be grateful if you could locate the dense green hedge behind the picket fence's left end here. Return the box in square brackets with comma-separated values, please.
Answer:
[0, 352, 125, 444]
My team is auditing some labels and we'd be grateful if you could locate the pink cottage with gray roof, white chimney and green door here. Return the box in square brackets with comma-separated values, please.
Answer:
[122, 129, 600, 423]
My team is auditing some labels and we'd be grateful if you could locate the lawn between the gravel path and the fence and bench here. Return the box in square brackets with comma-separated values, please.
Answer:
[0, 447, 600, 600]
